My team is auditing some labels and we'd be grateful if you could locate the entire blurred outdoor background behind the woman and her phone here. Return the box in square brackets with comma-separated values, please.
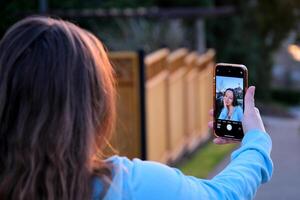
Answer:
[0, 0, 300, 199]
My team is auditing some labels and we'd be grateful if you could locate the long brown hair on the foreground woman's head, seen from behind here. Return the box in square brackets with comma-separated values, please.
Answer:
[0, 16, 115, 200]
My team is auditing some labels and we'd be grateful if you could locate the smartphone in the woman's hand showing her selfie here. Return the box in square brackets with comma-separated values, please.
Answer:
[213, 63, 248, 140]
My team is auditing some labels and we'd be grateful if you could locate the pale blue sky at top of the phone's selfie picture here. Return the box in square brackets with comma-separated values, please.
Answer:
[216, 76, 243, 92]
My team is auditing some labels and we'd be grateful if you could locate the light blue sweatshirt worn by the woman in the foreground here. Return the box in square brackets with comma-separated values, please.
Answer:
[93, 130, 273, 200]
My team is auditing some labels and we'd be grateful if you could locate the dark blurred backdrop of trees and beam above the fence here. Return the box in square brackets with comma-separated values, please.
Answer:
[0, 0, 300, 103]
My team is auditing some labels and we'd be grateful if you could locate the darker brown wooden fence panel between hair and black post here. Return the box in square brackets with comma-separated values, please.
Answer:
[109, 52, 142, 158]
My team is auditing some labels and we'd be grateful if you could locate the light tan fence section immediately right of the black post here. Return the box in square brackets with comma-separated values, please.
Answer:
[145, 49, 169, 163]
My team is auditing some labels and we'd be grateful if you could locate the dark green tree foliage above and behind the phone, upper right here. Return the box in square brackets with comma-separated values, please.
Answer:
[206, 0, 300, 100]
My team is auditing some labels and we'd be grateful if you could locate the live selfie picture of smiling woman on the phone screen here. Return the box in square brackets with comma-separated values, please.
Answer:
[216, 76, 243, 122]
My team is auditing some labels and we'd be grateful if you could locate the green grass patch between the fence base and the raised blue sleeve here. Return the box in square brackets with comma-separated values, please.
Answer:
[178, 142, 237, 178]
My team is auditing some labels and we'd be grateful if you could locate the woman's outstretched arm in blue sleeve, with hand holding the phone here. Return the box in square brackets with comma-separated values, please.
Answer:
[128, 87, 273, 199]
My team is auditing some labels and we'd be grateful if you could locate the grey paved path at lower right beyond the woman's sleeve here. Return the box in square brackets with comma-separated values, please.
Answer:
[210, 117, 300, 200]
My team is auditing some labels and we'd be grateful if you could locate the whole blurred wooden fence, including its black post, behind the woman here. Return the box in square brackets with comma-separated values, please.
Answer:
[110, 48, 215, 163]
